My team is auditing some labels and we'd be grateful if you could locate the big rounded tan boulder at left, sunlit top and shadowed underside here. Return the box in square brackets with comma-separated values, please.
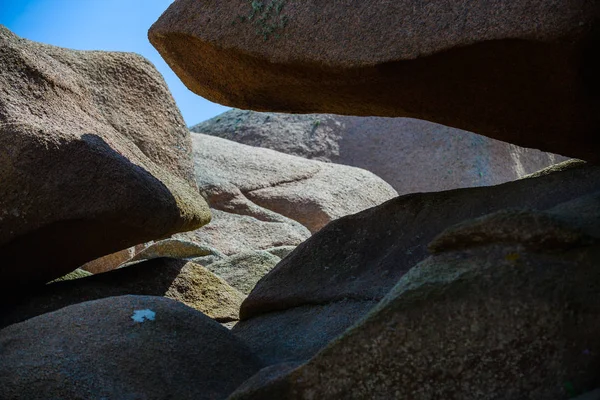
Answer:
[0, 27, 210, 287]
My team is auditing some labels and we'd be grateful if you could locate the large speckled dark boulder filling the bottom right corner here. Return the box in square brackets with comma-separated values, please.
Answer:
[230, 195, 600, 400]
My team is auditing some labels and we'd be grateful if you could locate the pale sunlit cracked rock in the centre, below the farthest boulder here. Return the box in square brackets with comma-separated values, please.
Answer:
[192, 133, 397, 231]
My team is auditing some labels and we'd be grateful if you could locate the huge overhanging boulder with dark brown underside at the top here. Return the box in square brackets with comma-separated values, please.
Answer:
[149, 0, 600, 162]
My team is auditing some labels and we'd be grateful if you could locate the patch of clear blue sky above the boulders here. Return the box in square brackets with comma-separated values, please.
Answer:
[0, 0, 229, 126]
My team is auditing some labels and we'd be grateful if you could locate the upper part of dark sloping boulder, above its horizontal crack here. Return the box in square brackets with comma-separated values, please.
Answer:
[241, 161, 600, 320]
